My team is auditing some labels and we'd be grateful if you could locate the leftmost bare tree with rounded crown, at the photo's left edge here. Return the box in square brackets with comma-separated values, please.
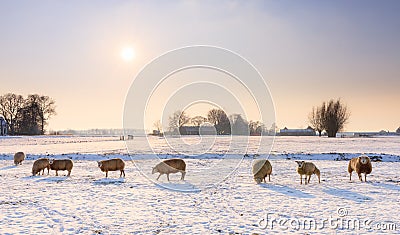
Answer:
[0, 93, 25, 135]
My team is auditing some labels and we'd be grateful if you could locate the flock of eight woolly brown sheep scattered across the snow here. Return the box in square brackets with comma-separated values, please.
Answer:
[10, 152, 372, 184]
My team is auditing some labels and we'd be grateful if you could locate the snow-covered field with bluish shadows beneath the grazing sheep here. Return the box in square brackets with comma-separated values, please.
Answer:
[0, 137, 400, 234]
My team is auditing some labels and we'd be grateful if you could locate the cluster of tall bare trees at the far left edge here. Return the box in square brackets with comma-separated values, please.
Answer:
[0, 93, 56, 135]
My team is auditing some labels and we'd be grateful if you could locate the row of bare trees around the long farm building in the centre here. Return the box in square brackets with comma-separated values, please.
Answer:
[162, 109, 276, 135]
